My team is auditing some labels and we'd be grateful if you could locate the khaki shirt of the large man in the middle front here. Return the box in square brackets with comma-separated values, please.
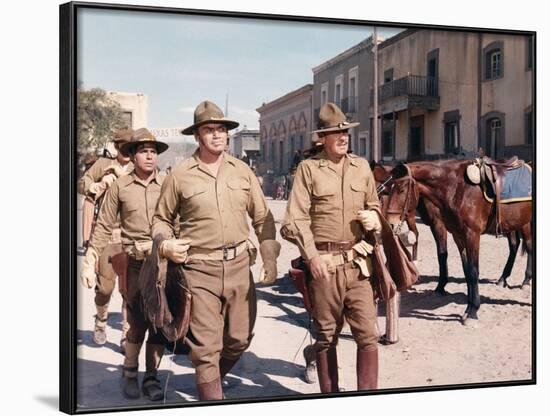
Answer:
[152, 150, 275, 249]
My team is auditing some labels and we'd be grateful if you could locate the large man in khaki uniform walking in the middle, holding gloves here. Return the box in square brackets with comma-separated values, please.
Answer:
[152, 101, 280, 400]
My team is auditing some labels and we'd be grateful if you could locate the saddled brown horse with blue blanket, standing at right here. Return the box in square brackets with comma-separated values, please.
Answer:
[386, 160, 533, 323]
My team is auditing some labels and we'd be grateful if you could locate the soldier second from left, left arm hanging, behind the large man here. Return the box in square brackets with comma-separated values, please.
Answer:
[81, 129, 168, 400]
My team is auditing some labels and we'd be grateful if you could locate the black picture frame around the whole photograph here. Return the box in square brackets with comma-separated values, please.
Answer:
[59, 2, 537, 414]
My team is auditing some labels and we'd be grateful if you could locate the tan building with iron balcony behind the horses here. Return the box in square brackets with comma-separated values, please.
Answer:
[370, 29, 533, 161]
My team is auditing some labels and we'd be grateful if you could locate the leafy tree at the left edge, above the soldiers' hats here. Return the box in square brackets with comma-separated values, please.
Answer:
[77, 86, 130, 155]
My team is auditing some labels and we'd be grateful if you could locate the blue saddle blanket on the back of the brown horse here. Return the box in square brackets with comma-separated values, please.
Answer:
[483, 164, 533, 204]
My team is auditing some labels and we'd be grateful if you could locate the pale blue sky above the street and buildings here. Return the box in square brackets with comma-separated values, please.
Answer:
[77, 9, 406, 136]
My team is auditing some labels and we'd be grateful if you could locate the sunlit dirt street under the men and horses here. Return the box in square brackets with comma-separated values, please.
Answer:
[77, 197, 532, 408]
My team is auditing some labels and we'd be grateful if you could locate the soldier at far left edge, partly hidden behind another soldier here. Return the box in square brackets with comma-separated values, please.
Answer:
[78, 129, 134, 351]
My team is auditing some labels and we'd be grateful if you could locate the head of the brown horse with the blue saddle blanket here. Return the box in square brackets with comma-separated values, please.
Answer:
[385, 163, 418, 228]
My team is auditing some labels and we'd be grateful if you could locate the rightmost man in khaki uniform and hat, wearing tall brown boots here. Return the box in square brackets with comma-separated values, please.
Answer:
[281, 103, 380, 393]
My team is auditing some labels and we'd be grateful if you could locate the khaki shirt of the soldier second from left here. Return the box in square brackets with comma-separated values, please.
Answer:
[90, 172, 163, 253]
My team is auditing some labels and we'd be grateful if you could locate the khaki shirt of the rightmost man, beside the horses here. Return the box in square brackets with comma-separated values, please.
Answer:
[281, 151, 380, 261]
